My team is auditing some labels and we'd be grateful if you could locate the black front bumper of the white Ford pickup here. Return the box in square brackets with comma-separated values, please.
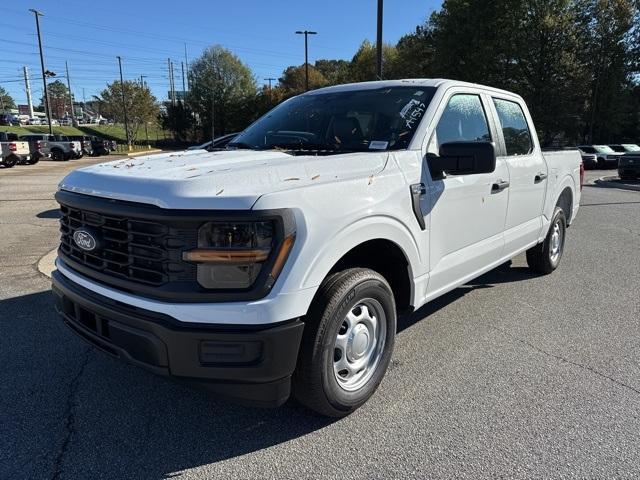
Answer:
[52, 271, 304, 407]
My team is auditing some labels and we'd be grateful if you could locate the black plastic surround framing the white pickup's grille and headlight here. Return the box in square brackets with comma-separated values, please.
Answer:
[55, 190, 295, 303]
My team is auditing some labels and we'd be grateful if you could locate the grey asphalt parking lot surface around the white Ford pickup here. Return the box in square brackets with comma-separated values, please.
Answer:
[0, 159, 640, 479]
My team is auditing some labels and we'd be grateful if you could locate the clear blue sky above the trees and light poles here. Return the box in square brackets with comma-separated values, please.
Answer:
[0, 0, 441, 107]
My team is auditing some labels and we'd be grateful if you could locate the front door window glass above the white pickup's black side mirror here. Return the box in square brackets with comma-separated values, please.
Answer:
[432, 94, 491, 147]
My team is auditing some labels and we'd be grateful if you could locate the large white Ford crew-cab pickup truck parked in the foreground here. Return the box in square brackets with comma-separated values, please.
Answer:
[53, 80, 581, 416]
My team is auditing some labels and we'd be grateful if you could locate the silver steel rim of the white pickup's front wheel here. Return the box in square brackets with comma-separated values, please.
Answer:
[333, 298, 387, 392]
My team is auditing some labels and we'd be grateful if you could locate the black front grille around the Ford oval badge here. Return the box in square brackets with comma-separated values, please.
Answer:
[60, 205, 197, 286]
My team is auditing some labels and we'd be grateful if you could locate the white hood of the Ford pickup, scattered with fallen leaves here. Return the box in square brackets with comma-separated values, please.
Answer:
[59, 150, 388, 210]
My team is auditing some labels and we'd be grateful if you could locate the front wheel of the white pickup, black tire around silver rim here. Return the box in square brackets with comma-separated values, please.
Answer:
[293, 268, 397, 417]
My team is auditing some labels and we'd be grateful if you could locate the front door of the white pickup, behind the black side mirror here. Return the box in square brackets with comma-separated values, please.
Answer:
[427, 92, 509, 299]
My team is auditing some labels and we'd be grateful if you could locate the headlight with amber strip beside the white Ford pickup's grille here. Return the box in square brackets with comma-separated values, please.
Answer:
[182, 220, 295, 289]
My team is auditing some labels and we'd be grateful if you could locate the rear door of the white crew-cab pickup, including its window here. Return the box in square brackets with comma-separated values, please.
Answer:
[491, 95, 549, 255]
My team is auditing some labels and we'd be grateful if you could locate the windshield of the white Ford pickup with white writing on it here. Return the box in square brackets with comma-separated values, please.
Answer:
[229, 86, 435, 153]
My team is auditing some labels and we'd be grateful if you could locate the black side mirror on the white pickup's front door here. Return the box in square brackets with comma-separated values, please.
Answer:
[427, 142, 496, 179]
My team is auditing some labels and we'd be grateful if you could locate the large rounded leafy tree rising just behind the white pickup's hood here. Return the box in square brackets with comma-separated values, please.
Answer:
[188, 45, 257, 138]
